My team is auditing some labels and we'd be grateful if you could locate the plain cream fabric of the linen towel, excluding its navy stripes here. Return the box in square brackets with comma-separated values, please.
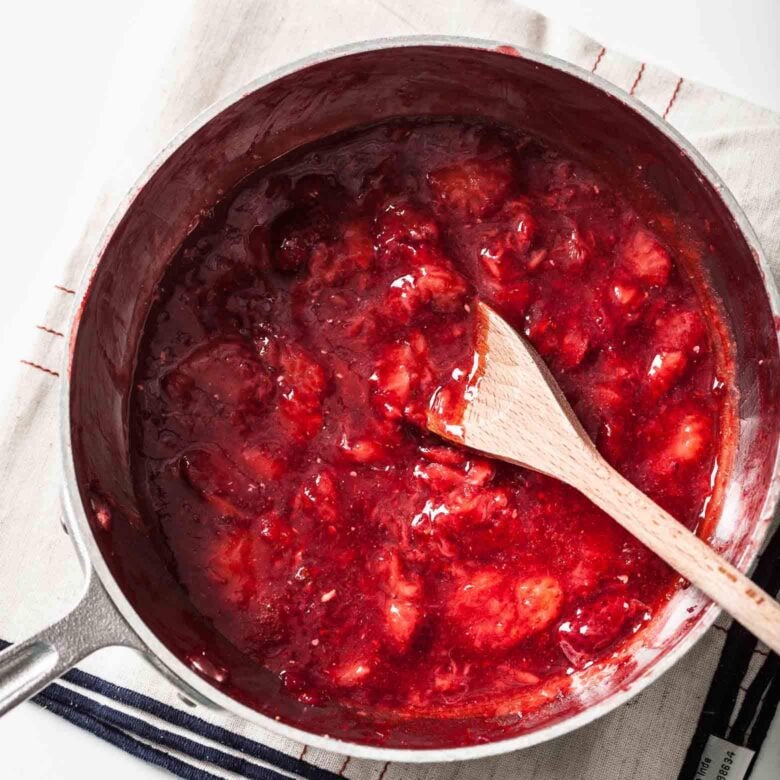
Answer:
[0, 0, 780, 780]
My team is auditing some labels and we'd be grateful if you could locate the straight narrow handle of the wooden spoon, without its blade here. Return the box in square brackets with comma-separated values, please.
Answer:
[572, 456, 780, 653]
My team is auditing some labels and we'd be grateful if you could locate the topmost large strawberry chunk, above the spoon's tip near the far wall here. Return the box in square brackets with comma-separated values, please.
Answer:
[428, 156, 514, 219]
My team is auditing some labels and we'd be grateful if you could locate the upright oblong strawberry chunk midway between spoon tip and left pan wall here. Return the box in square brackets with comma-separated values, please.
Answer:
[277, 344, 326, 438]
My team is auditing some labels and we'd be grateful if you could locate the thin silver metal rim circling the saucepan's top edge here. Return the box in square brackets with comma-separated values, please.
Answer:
[60, 35, 780, 763]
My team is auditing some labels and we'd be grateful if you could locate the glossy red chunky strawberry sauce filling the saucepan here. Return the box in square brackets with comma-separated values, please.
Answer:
[131, 120, 725, 717]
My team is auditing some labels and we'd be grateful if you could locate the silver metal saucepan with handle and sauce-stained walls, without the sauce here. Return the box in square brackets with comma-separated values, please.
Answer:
[0, 38, 780, 761]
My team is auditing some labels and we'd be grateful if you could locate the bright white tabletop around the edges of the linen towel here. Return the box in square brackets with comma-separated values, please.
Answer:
[0, 0, 780, 780]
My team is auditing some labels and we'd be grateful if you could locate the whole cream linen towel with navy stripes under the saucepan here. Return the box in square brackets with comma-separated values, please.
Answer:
[0, 0, 780, 780]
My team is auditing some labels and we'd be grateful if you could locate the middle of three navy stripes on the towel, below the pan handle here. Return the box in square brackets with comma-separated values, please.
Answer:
[39, 684, 286, 780]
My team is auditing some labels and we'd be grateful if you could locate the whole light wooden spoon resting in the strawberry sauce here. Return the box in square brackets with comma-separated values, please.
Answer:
[428, 303, 780, 653]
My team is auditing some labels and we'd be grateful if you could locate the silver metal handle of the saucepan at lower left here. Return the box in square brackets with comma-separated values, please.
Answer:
[0, 572, 144, 716]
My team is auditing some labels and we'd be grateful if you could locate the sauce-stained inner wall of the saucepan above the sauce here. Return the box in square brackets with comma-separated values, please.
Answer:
[70, 45, 780, 748]
